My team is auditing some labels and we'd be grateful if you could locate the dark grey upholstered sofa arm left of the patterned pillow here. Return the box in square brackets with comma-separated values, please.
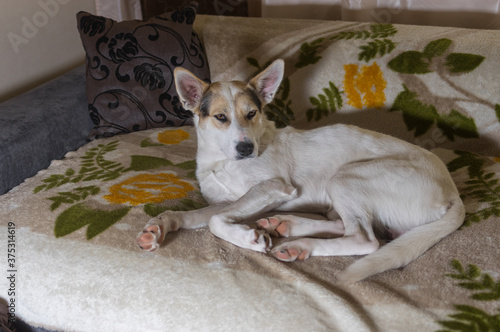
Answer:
[0, 65, 93, 194]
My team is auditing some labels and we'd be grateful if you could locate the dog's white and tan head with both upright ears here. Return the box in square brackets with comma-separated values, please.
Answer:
[174, 60, 284, 159]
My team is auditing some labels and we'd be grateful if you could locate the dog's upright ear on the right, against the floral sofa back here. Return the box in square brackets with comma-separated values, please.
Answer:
[248, 59, 285, 104]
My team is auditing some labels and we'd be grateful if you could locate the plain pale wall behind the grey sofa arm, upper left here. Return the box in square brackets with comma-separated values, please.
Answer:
[0, 0, 95, 102]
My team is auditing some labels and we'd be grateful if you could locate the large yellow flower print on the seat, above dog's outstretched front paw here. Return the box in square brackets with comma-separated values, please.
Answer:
[104, 173, 195, 206]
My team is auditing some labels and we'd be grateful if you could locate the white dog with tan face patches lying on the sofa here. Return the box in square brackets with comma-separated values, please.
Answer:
[137, 60, 465, 282]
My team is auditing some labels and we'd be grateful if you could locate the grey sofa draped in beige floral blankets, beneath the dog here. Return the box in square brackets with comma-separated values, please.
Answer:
[0, 3, 500, 331]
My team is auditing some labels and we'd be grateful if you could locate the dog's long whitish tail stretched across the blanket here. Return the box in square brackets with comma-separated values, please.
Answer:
[338, 197, 465, 283]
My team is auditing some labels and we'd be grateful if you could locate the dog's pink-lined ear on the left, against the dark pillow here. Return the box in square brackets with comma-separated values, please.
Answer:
[174, 67, 208, 112]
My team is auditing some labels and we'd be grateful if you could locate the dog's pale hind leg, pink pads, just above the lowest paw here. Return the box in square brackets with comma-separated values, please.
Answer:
[257, 215, 344, 238]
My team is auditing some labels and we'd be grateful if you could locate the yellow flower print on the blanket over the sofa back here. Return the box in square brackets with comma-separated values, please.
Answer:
[344, 62, 387, 109]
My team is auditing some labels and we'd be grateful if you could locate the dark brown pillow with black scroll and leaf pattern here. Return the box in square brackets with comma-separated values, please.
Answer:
[77, 2, 210, 139]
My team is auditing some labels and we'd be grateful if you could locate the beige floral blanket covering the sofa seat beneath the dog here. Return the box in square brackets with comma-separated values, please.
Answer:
[0, 127, 500, 331]
